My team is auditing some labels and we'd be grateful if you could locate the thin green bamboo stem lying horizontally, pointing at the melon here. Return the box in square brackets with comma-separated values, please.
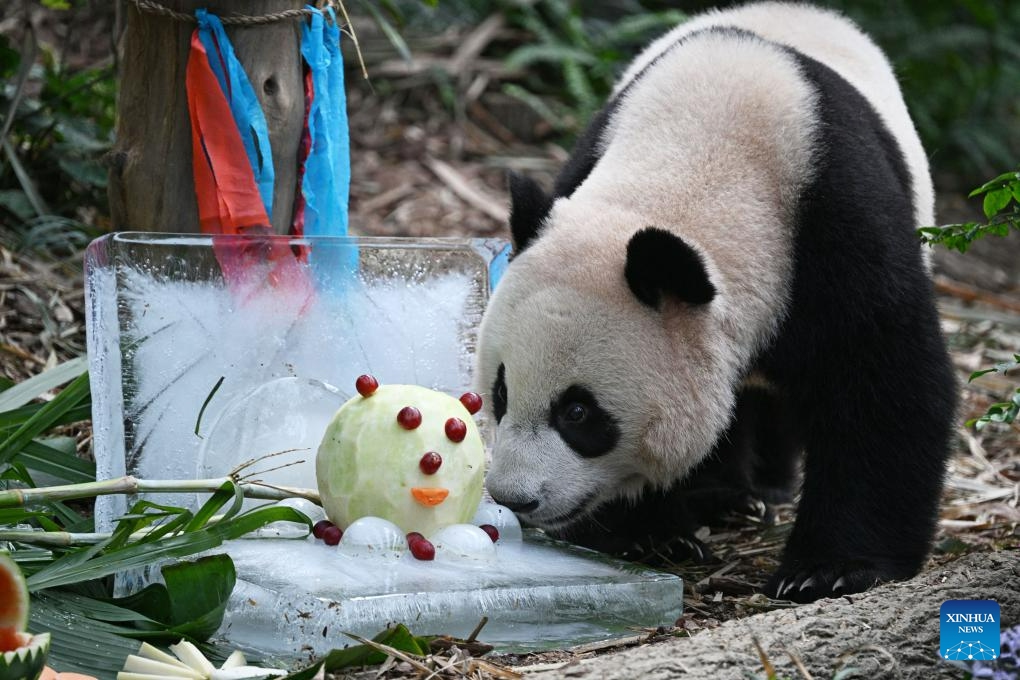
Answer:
[0, 475, 319, 508]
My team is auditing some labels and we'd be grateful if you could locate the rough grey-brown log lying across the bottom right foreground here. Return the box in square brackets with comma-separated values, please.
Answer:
[527, 551, 1020, 680]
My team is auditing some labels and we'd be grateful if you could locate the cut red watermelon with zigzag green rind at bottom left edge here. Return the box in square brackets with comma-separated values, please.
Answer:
[0, 554, 50, 680]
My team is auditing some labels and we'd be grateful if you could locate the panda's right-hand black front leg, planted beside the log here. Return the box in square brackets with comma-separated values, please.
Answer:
[765, 287, 956, 601]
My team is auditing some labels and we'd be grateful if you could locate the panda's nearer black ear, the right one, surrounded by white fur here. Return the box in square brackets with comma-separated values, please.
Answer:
[623, 226, 715, 309]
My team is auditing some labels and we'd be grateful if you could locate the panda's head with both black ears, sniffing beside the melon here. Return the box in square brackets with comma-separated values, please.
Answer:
[476, 180, 732, 529]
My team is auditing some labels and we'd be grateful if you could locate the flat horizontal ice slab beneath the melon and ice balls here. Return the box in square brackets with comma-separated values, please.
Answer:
[217, 531, 683, 659]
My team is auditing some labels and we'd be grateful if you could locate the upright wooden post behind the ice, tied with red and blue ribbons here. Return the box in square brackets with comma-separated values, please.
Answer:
[109, 0, 305, 233]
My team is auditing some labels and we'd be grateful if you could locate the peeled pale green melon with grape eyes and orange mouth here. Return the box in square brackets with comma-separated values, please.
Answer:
[315, 384, 486, 536]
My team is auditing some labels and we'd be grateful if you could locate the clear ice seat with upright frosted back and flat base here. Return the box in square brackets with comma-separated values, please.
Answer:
[86, 233, 682, 657]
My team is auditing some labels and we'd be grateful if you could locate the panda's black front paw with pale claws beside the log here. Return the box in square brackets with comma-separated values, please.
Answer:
[764, 562, 895, 603]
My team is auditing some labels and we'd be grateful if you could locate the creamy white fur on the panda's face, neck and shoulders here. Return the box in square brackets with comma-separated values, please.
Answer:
[477, 17, 814, 523]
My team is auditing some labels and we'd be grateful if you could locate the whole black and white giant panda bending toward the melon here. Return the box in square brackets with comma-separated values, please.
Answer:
[476, 2, 957, 601]
